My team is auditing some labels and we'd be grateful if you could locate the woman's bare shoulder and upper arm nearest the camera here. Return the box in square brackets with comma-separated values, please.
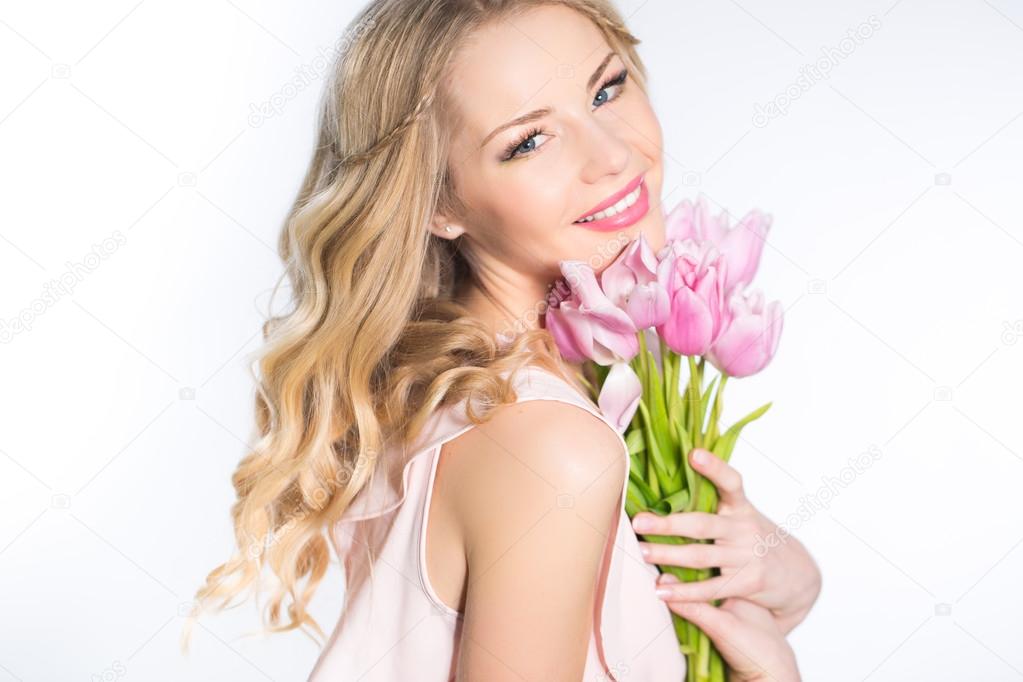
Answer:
[445, 401, 625, 682]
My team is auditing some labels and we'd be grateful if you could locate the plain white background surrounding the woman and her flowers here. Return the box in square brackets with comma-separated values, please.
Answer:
[0, 0, 1023, 682]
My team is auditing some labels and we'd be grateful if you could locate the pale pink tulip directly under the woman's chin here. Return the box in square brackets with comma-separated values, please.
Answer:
[601, 233, 670, 329]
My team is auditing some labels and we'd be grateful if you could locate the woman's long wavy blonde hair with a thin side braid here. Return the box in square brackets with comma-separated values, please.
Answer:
[181, 0, 647, 651]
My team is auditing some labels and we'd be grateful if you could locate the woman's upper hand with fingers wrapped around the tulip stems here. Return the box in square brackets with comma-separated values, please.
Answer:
[632, 448, 820, 633]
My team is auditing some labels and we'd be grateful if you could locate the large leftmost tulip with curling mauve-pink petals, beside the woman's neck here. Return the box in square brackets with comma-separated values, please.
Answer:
[545, 261, 639, 365]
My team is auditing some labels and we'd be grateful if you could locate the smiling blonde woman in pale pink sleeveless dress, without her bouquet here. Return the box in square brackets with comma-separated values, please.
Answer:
[186, 0, 819, 682]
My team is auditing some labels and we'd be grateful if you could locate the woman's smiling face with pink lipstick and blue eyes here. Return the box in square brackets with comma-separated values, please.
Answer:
[433, 5, 664, 288]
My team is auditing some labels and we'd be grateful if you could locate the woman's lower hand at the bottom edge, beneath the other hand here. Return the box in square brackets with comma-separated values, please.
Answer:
[658, 574, 801, 682]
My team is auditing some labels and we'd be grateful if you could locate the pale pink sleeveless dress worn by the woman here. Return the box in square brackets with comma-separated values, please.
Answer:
[308, 365, 685, 682]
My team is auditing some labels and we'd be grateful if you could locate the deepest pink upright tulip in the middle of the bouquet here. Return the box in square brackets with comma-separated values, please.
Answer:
[657, 239, 727, 356]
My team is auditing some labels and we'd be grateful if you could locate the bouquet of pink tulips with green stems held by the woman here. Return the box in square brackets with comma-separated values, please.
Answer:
[545, 195, 782, 682]
